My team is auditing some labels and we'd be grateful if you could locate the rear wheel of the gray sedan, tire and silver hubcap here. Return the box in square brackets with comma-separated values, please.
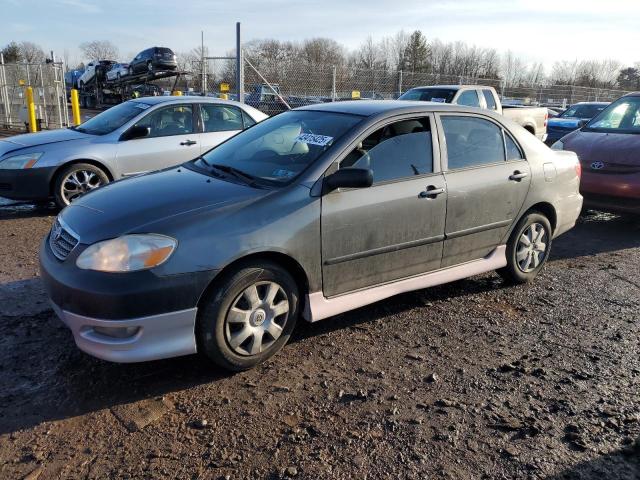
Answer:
[498, 212, 553, 283]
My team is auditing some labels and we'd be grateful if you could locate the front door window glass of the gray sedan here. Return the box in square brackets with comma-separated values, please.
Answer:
[340, 118, 433, 183]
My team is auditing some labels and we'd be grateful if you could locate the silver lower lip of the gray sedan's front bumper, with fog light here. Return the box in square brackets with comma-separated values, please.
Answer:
[53, 303, 197, 363]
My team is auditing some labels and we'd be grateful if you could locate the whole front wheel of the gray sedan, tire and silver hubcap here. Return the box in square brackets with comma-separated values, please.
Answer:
[197, 262, 299, 371]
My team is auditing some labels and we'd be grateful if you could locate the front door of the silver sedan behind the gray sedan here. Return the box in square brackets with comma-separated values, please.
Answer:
[117, 104, 200, 177]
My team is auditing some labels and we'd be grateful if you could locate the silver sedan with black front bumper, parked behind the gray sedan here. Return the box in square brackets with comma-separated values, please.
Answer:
[0, 97, 267, 207]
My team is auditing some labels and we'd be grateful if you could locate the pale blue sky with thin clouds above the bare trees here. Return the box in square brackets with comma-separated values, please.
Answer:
[0, 0, 640, 65]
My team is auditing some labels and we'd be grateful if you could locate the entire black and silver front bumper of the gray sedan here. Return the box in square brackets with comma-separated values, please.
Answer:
[40, 236, 217, 362]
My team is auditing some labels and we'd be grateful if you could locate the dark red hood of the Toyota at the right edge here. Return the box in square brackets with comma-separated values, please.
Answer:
[562, 130, 640, 165]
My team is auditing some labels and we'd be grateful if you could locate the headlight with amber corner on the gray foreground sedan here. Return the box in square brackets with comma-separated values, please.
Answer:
[76, 234, 178, 273]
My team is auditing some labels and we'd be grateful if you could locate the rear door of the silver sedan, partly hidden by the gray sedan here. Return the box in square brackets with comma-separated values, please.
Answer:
[200, 103, 249, 153]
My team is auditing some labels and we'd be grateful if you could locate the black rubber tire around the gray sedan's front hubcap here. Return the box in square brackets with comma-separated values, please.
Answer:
[196, 261, 300, 372]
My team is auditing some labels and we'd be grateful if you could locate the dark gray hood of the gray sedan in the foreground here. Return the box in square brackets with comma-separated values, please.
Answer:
[60, 167, 270, 244]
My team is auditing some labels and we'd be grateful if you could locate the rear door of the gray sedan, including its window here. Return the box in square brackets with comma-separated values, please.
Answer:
[438, 114, 531, 267]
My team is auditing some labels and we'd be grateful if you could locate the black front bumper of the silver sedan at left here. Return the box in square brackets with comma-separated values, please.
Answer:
[0, 167, 55, 200]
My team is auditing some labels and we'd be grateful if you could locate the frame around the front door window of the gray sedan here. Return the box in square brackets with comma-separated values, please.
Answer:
[332, 112, 443, 188]
